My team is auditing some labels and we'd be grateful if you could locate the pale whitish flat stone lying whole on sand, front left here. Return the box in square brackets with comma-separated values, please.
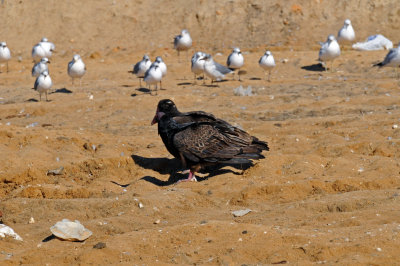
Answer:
[50, 219, 92, 241]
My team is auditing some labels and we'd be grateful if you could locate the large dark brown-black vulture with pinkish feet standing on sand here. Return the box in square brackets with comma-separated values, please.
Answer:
[151, 99, 269, 181]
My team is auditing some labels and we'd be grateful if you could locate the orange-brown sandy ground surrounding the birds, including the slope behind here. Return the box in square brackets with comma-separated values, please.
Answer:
[0, 0, 400, 265]
